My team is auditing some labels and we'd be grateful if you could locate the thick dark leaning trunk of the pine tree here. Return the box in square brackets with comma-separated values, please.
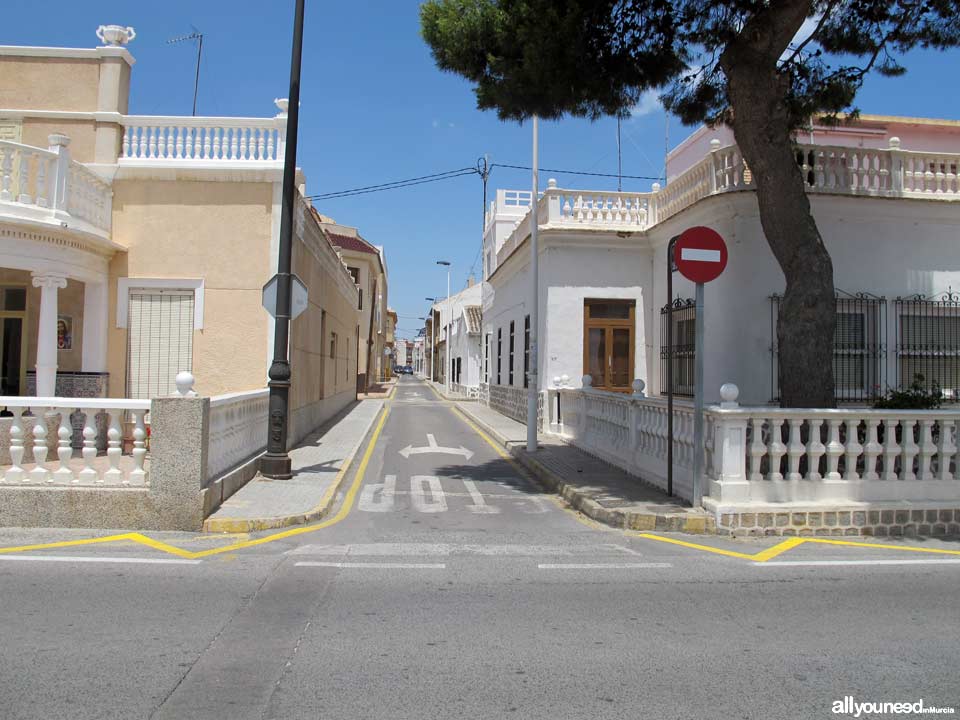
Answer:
[720, 0, 836, 407]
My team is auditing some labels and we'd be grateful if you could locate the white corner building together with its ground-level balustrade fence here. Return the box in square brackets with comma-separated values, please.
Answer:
[482, 116, 960, 524]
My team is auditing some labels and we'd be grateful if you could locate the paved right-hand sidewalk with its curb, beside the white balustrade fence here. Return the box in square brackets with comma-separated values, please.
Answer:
[456, 402, 716, 533]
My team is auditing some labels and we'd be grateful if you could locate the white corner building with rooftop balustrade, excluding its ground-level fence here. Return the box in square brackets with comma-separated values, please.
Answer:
[483, 116, 960, 420]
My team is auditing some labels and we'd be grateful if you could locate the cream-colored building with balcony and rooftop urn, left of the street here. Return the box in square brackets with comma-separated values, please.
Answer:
[0, 26, 362, 441]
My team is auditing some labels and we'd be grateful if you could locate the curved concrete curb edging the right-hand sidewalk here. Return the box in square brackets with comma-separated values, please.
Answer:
[457, 405, 717, 535]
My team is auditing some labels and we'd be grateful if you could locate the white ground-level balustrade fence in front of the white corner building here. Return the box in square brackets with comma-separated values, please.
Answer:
[548, 386, 960, 506]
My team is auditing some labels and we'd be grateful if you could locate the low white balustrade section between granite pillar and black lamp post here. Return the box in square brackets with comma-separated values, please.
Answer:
[207, 389, 270, 479]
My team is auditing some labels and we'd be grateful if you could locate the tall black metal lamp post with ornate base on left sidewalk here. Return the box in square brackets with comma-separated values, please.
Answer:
[260, 0, 304, 480]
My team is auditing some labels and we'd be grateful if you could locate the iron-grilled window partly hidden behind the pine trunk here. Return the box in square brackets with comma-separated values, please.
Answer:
[770, 290, 887, 402]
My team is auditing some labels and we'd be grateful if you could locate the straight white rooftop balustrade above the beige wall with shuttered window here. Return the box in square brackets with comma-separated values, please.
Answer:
[120, 115, 286, 163]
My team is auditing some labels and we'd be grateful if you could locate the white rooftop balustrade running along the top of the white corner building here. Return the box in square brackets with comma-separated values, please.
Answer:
[486, 138, 960, 255]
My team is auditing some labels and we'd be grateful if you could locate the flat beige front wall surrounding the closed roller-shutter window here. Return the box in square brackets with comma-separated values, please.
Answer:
[108, 180, 272, 397]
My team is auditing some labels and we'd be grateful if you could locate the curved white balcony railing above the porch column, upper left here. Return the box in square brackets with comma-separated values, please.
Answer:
[0, 135, 113, 236]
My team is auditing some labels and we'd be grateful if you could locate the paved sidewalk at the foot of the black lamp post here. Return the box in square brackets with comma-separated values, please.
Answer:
[203, 400, 383, 532]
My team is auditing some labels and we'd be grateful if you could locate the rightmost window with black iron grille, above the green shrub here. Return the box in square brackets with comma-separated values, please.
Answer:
[896, 291, 960, 401]
